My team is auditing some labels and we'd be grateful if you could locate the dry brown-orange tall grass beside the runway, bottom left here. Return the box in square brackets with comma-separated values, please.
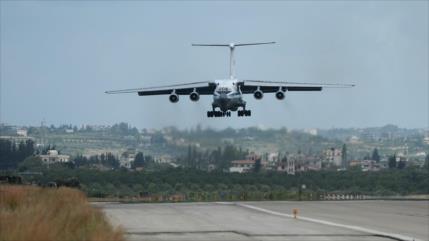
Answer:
[0, 185, 124, 241]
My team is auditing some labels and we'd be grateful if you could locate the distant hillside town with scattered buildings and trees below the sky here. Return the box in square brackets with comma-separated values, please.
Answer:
[0, 123, 429, 175]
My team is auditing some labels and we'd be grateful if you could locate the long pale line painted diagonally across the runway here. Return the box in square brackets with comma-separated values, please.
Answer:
[234, 203, 422, 241]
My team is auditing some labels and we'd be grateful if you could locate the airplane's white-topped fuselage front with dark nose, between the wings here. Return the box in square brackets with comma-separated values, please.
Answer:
[212, 79, 246, 112]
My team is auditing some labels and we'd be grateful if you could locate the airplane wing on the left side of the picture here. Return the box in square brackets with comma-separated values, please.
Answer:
[106, 81, 216, 96]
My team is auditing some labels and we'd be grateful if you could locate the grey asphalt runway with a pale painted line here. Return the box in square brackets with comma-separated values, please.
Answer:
[94, 201, 429, 241]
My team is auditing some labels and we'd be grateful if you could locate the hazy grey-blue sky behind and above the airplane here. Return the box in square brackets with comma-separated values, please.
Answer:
[0, 1, 429, 128]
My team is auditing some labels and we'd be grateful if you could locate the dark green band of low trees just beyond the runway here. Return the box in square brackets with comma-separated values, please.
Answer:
[27, 168, 429, 201]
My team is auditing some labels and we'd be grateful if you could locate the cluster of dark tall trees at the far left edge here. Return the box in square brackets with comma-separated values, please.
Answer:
[0, 139, 34, 170]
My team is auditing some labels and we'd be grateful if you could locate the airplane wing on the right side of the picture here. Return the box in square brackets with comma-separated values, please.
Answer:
[239, 80, 354, 94]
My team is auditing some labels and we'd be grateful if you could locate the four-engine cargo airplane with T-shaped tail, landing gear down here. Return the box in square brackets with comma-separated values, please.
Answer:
[106, 42, 354, 117]
